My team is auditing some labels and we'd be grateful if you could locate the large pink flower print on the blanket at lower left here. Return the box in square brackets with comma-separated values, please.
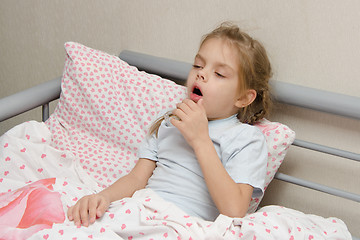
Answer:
[0, 178, 65, 240]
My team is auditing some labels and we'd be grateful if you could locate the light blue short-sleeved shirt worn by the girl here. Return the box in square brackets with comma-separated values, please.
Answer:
[138, 115, 267, 221]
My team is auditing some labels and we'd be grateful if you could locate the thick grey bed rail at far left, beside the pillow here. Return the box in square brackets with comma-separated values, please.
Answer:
[0, 77, 61, 122]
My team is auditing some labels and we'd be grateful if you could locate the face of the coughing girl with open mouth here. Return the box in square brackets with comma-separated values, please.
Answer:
[187, 38, 246, 120]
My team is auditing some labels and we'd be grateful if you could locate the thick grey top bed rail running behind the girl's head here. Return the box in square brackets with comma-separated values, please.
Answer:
[120, 50, 360, 122]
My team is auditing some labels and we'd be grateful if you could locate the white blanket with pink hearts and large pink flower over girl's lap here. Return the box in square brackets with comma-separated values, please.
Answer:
[0, 122, 351, 240]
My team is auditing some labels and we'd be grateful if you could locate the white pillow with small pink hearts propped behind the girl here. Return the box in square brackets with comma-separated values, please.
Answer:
[46, 42, 295, 211]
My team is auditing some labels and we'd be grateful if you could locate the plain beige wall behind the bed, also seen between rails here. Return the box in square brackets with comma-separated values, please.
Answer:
[0, 0, 360, 236]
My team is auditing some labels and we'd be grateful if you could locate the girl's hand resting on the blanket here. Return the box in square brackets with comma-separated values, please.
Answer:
[67, 194, 110, 227]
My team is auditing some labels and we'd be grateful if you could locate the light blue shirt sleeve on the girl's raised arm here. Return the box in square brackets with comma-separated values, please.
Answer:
[222, 125, 268, 197]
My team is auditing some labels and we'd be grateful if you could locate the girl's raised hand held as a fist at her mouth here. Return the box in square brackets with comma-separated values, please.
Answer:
[171, 99, 210, 148]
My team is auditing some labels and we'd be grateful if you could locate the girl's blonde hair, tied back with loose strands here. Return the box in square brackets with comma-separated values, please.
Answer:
[149, 22, 272, 135]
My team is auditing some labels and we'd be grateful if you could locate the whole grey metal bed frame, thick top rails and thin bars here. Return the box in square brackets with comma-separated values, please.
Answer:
[0, 50, 360, 240]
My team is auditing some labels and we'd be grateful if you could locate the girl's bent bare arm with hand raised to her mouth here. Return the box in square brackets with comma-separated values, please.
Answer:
[171, 99, 253, 217]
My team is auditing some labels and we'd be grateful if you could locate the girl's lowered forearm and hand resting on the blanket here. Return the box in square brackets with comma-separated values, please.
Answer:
[67, 158, 156, 226]
